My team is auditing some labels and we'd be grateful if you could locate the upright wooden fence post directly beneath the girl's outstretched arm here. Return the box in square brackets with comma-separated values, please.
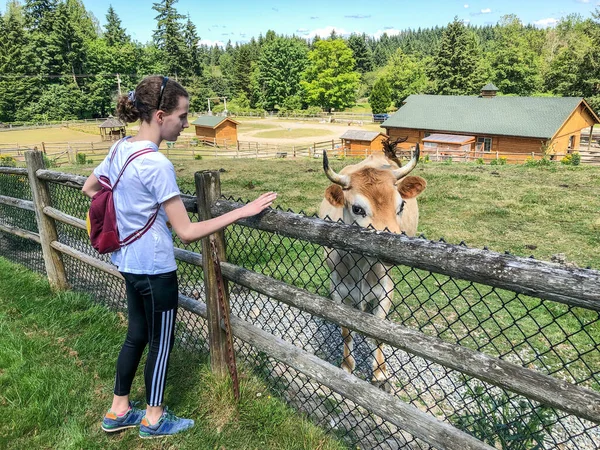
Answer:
[194, 171, 229, 376]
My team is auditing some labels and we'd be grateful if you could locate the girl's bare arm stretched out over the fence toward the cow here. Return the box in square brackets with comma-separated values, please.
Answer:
[163, 192, 277, 244]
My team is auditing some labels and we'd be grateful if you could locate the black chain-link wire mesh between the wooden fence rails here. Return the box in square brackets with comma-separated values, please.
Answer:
[0, 174, 600, 449]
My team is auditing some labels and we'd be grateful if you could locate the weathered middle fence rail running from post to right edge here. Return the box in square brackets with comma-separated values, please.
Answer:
[221, 263, 600, 423]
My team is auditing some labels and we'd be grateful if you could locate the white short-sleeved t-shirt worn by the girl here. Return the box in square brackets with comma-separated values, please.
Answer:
[94, 138, 180, 275]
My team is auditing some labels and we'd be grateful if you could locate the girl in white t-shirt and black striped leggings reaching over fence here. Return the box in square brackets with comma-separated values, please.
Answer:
[82, 76, 277, 438]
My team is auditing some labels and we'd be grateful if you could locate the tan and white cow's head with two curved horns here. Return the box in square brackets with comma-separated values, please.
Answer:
[323, 144, 427, 233]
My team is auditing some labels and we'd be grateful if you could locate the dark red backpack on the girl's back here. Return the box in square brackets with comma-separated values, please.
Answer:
[87, 141, 160, 253]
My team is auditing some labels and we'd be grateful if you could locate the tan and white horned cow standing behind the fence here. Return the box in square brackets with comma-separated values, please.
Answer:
[319, 145, 427, 390]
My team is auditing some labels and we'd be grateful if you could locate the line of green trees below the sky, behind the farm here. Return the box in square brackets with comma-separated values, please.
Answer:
[0, 0, 600, 122]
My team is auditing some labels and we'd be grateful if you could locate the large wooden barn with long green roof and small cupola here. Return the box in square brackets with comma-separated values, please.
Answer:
[381, 84, 600, 161]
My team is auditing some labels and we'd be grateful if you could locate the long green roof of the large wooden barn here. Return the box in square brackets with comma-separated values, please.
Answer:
[381, 95, 583, 138]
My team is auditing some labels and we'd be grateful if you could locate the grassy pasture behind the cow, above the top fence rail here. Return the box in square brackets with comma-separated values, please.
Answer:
[61, 159, 600, 269]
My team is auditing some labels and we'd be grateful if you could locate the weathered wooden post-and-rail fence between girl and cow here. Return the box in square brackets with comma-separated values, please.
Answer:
[0, 152, 600, 450]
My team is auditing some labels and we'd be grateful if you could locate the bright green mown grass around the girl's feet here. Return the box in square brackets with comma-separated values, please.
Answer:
[0, 258, 343, 449]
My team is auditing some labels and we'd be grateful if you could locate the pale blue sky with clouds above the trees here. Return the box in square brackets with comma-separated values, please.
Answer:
[4, 0, 600, 45]
